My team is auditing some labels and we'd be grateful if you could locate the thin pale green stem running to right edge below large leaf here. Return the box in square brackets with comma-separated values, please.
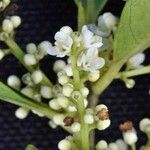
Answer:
[116, 66, 150, 78]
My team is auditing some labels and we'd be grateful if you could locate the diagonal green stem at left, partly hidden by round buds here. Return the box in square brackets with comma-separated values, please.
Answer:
[4, 38, 53, 87]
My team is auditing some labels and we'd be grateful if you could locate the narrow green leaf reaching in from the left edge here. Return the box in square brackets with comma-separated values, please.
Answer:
[0, 81, 56, 118]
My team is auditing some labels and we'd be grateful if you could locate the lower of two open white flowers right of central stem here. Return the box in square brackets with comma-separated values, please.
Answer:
[77, 48, 105, 72]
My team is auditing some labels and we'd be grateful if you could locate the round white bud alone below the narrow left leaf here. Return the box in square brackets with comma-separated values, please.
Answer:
[15, 107, 29, 119]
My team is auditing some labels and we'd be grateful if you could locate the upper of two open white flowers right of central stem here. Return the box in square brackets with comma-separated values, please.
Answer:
[81, 25, 103, 48]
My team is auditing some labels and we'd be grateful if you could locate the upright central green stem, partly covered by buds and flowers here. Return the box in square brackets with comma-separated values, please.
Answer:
[71, 46, 89, 150]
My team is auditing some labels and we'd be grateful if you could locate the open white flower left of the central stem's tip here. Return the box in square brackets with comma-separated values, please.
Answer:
[47, 26, 73, 57]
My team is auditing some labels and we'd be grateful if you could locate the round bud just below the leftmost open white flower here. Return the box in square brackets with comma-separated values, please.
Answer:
[53, 60, 66, 73]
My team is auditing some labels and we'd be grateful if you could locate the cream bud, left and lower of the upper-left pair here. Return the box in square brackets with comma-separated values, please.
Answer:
[2, 19, 14, 33]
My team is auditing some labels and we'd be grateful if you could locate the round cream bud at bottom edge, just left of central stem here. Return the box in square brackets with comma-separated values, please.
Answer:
[58, 139, 72, 150]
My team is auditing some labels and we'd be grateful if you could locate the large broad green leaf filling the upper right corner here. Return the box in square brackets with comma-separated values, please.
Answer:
[114, 0, 150, 61]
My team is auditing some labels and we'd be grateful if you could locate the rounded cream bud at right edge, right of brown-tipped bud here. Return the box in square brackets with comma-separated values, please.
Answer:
[140, 118, 150, 132]
